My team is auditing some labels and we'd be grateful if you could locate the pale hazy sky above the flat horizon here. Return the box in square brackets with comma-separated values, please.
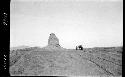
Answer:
[10, 0, 123, 48]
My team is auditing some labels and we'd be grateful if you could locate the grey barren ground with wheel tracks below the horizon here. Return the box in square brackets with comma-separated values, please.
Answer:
[9, 47, 122, 76]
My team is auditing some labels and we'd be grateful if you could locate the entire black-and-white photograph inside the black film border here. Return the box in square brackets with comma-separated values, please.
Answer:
[9, 0, 123, 77]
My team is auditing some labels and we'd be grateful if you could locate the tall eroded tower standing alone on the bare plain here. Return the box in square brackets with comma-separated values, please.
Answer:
[48, 33, 60, 47]
